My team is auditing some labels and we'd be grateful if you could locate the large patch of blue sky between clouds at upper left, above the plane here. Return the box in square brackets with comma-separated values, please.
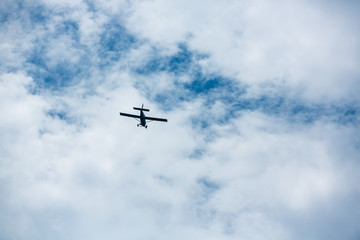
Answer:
[21, 5, 136, 90]
